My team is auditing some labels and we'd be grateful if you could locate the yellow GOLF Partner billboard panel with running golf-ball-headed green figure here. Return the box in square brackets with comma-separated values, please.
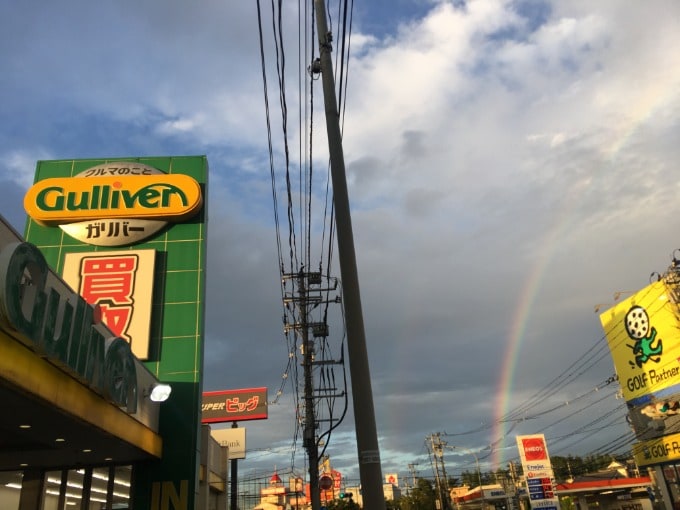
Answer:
[600, 281, 680, 402]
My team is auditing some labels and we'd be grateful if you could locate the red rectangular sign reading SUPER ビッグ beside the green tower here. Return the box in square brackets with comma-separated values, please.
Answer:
[201, 388, 267, 423]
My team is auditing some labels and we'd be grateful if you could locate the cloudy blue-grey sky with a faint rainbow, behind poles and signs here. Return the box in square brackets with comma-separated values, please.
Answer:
[0, 0, 680, 486]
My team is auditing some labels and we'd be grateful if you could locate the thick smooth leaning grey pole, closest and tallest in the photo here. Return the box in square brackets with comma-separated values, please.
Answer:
[314, 0, 385, 510]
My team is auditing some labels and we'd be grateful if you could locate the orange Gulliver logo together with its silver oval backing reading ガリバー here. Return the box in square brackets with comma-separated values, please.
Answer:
[24, 162, 203, 246]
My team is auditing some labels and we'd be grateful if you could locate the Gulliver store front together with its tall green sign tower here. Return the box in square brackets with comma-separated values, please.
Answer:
[0, 156, 210, 510]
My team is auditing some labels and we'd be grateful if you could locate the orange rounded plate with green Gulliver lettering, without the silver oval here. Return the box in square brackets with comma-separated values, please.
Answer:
[24, 174, 203, 225]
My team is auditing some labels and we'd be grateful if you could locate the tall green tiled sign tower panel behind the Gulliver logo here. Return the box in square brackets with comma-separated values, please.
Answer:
[25, 156, 208, 510]
